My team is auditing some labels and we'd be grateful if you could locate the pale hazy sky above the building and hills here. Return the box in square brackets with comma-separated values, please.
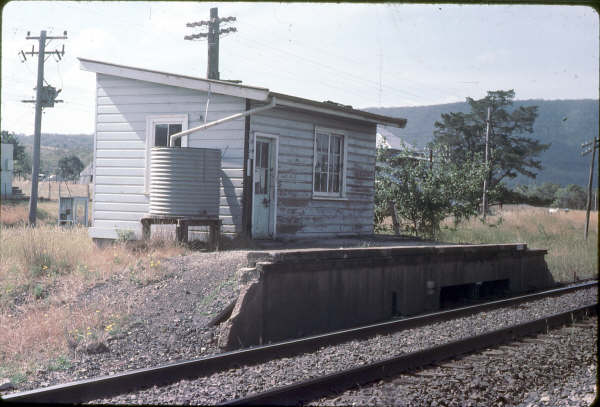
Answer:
[0, 1, 600, 134]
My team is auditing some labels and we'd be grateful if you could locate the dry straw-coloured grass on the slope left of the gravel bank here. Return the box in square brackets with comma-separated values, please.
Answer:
[0, 202, 186, 382]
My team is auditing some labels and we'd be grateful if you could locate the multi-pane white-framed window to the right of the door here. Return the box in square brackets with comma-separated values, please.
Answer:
[313, 128, 346, 197]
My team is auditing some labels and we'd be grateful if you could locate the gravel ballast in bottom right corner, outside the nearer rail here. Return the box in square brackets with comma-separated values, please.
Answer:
[311, 317, 598, 407]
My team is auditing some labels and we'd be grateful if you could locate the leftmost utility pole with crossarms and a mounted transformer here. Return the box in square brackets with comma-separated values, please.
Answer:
[20, 31, 67, 226]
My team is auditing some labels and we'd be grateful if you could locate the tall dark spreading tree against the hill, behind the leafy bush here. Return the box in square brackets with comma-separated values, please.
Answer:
[434, 89, 550, 204]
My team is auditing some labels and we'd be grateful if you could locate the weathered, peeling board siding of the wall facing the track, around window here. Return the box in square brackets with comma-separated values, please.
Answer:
[250, 108, 376, 238]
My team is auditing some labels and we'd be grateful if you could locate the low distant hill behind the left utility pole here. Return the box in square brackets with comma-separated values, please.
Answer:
[17, 133, 94, 174]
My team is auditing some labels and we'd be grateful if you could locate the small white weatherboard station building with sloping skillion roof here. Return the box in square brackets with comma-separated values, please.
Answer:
[80, 58, 406, 239]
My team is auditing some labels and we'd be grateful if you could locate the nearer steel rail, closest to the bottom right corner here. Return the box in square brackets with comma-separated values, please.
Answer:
[218, 303, 598, 406]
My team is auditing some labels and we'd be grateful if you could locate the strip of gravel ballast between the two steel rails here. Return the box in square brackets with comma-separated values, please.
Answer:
[92, 287, 597, 405]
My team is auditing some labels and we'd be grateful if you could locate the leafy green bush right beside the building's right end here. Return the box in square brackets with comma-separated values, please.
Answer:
[375, 146, 485, 238]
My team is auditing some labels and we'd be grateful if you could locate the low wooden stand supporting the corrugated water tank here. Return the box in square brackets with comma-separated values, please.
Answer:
[141, 216, 221, 250]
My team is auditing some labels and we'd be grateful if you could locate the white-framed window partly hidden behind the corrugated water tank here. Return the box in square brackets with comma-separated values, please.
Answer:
[144, 114, 188, 194]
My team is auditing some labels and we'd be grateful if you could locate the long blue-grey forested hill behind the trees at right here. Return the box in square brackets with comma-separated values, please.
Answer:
[364, 99, 598, 186]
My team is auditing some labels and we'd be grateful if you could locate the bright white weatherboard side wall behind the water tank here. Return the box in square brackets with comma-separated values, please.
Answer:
[93, 74, 245, 237]
